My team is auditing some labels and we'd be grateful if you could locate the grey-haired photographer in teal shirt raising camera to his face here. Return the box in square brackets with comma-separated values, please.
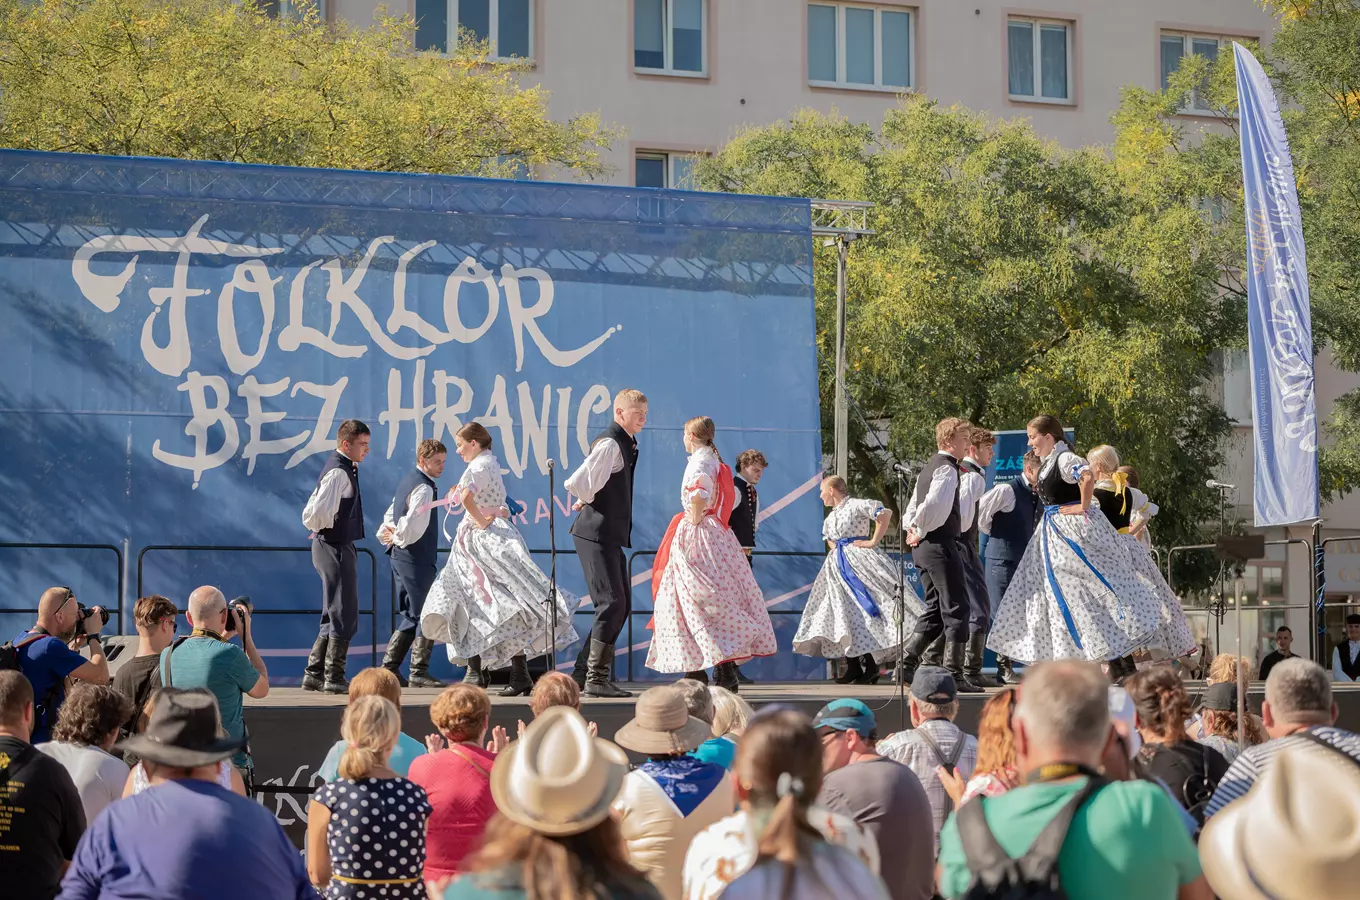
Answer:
[156, 585, 269, 787]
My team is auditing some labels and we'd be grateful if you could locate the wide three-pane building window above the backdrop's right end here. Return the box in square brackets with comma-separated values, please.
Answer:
[808, 3, 913, 90]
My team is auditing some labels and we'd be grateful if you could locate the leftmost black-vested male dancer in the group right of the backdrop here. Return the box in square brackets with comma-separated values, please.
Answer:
[900, 419, 982, 693]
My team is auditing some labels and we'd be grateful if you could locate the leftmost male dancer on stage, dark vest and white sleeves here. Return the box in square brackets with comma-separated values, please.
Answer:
[302, 419, 370, 693]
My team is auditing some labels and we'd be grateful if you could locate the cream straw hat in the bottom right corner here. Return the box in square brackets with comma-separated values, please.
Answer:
[1200, 746, 1360, 900]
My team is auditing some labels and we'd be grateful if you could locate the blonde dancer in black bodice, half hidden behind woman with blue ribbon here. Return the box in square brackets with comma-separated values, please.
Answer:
[1087, 443, 1198, 682]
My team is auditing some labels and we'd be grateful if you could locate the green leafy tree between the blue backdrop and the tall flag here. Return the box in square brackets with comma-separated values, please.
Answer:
[698, 95, 1240, 565]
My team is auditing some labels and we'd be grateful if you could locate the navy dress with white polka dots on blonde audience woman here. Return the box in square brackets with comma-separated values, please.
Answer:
[311, 778, 430, 900]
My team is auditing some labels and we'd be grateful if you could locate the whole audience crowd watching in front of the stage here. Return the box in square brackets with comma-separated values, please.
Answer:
[0, 587, 1360, 900]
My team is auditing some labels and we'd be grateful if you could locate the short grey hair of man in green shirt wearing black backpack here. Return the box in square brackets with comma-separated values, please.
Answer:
[1016, 659, 1110, 750]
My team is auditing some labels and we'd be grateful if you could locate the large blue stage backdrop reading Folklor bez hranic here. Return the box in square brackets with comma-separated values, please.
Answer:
[0, 151, 821, 684]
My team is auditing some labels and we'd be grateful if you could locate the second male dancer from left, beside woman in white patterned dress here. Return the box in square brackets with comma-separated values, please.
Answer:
[378, 438, 446, 688]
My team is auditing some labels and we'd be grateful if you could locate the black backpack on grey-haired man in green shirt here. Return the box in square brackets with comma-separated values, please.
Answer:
[955, 778, 1108, 900]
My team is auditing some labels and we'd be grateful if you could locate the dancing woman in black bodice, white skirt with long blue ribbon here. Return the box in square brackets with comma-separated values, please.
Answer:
[987, 416, 1160, 662]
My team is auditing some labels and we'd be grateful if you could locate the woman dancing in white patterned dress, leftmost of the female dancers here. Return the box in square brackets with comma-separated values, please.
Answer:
[420, 421, 579, 696]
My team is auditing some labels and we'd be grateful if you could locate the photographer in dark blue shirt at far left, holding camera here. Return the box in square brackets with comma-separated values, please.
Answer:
[3, 587, 109, 744]
